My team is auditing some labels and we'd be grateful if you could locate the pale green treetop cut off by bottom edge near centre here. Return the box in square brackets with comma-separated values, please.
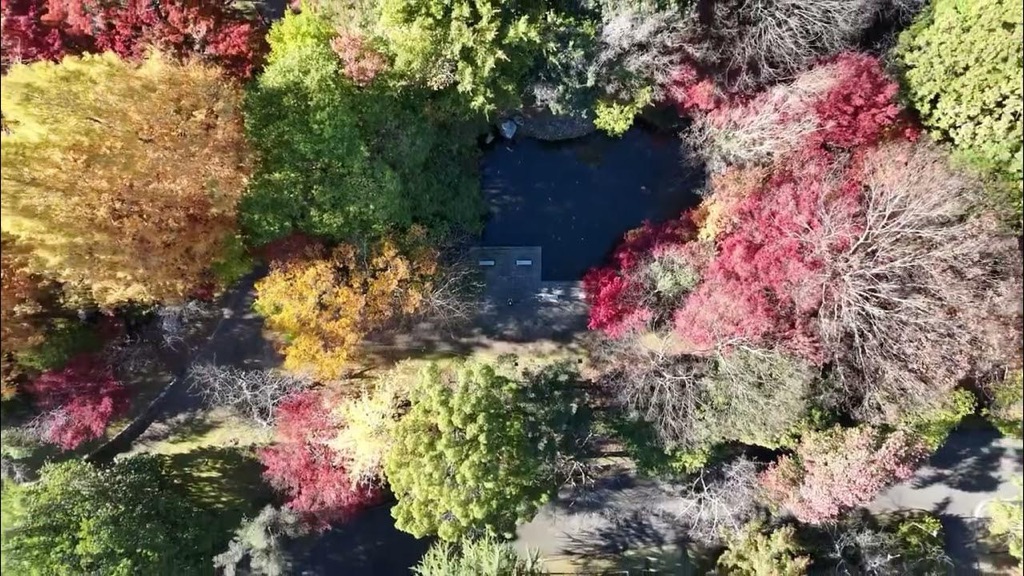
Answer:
[413, 536, 547, 576]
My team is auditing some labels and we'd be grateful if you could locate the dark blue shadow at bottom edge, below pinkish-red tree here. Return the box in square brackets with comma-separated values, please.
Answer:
[293, 505, 431, 576]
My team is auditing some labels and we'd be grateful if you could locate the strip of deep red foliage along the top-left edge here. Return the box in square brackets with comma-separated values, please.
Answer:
[3, 0, 267, 78]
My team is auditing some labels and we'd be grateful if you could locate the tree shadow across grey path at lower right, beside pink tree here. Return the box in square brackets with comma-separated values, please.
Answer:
[912, 426, 1022, 492]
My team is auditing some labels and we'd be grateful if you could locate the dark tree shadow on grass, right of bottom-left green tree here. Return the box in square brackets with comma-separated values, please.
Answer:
[161, 447, 273, 547]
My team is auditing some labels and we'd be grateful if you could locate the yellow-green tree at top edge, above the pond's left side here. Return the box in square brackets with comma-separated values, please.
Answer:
[375, 0, 547, 113]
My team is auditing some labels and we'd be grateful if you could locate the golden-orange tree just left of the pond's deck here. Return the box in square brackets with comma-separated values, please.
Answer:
[256, 230, 437, 379]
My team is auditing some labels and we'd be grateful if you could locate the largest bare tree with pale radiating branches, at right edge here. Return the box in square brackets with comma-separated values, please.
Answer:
[812, 143, 1020, 421]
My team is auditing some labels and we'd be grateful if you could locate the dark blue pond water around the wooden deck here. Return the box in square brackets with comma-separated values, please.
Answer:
[482, 126, 703, 281]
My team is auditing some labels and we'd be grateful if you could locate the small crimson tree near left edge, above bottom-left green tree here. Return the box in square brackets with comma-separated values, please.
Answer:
[28, 356, 129, 450]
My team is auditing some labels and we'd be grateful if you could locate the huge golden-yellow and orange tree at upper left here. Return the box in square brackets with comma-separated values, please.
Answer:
[2, 53, 248, 306]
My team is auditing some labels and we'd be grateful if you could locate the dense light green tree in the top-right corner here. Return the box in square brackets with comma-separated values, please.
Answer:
[897, 0, 1024, 224]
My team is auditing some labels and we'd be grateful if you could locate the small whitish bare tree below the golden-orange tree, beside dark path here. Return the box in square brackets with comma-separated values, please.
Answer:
[188, 364, 310, 426]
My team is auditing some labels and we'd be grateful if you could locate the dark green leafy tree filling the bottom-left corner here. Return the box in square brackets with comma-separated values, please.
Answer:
[2, 456, 213, 576]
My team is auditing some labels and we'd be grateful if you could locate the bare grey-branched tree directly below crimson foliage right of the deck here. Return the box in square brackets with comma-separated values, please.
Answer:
[601, 341, 712, 447]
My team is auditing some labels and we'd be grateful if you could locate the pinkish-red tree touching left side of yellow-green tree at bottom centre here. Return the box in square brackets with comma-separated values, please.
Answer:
[260, 390, 380, 530]
